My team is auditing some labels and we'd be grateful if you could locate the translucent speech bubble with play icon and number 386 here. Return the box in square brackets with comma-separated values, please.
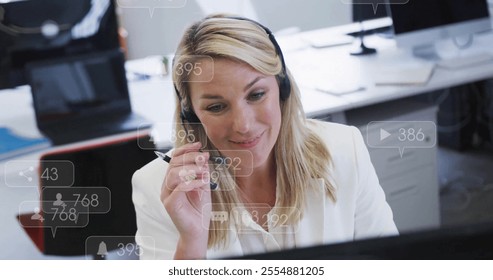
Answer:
[366, 121, 437, 158]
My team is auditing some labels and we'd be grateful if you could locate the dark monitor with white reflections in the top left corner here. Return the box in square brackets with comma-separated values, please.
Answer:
[0, 0, 120, 89]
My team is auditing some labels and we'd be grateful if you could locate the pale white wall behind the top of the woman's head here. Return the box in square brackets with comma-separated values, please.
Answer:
[119, 0, 351, 59]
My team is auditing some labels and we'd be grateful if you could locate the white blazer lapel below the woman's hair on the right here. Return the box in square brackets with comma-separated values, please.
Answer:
[295, 179, 327, 247]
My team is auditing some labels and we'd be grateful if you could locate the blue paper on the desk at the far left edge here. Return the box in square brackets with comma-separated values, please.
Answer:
[0, 127, 51, 161]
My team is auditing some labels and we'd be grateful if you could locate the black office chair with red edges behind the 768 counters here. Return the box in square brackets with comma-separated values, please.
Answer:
[18, 133, 156, 256]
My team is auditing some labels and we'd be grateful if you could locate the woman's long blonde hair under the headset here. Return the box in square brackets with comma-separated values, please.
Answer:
[173, 15, 336, 248]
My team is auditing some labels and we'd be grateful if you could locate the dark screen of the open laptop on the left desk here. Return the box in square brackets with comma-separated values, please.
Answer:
[26, 49, 130, 127]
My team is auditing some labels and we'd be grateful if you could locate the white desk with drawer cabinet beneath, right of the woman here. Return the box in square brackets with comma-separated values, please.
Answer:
[280, 23, 493, 232]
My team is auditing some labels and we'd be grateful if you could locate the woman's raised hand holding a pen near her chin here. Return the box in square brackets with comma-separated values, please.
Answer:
[161, 142, 212, 259]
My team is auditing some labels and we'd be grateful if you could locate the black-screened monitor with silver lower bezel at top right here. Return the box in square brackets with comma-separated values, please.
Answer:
[389, 0, 491, 58]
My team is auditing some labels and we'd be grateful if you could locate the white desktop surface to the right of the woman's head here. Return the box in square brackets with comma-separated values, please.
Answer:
[279, 23, 493, 115]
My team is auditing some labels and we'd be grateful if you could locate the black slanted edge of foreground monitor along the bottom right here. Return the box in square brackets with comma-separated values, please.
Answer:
[229, 223, 493, 260]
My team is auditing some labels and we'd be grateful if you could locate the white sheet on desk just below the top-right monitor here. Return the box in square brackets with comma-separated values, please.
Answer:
[374, 62, 435, 86]
